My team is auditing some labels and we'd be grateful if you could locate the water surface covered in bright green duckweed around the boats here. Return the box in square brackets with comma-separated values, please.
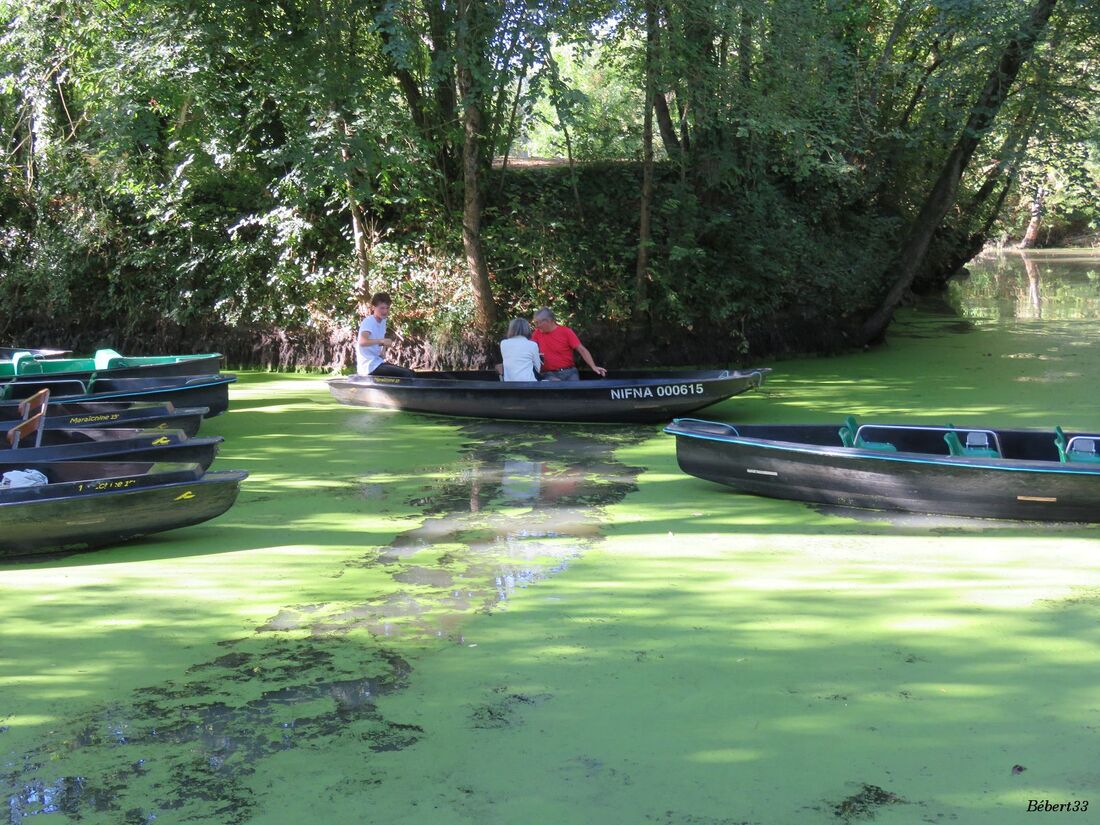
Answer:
[0, 254, 1100, 825]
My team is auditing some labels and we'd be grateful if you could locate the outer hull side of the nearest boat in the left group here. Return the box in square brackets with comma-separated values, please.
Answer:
[0, 471, 248, 558]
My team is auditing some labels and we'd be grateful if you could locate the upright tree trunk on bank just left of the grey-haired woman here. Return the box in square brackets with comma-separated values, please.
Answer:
[457, 0, 496, 333]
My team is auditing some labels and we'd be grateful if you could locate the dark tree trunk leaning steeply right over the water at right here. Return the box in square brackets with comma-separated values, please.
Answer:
[859, 0, 1057, 343]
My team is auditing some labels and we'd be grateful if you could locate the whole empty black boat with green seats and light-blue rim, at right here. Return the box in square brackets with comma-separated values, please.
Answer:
[664, 419, 1100, 521]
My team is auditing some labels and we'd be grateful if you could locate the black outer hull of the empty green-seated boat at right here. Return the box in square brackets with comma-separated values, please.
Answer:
[667, 425, 1100, 523]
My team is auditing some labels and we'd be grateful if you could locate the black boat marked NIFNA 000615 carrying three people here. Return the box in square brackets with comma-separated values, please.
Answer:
[329, 369, 770, 424]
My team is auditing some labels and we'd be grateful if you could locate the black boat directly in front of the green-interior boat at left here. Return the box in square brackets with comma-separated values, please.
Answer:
[0, 374, 237, 418]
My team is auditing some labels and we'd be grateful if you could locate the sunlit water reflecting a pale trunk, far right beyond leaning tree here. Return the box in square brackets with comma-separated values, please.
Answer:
[948, 250, 1100, 321]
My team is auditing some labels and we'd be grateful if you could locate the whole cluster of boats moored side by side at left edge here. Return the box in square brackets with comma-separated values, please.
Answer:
[0, 350, 248, 557]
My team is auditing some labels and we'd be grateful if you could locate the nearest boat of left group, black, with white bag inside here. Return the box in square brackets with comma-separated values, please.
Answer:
[0, 461, 248, 558]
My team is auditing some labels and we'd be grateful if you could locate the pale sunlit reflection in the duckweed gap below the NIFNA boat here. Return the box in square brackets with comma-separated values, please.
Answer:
[272, 421, 648, 644]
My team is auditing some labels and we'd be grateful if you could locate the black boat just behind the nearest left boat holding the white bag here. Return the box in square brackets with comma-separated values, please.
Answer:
[0, 429, 224, 470]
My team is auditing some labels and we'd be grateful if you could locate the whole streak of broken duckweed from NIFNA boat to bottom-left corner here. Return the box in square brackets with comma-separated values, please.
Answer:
[0, 421, 651, 825]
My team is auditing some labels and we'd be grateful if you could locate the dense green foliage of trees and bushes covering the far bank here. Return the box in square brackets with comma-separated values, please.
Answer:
[0, 0, 1100, 359]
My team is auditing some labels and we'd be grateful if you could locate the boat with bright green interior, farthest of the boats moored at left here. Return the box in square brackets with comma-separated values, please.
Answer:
[0, 350, 221, 382]
